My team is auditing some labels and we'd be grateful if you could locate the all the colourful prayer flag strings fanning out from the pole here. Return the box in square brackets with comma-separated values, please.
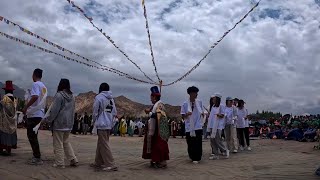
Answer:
[0, 0, 261, 86]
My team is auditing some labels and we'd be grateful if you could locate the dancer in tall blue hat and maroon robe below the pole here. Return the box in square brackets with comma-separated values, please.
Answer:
[142, 86, 170, 168]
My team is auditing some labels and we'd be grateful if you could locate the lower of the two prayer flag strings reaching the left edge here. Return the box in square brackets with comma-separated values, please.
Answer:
[0, 30, 154, 84]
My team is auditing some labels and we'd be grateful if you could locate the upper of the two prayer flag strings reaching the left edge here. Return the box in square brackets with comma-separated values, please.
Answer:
[0, 16, 149, 83]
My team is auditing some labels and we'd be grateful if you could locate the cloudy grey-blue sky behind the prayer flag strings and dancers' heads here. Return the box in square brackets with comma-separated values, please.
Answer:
[0, 0, 320, 114]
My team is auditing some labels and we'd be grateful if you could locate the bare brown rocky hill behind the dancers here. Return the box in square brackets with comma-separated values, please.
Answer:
[47, 91, 180, 117]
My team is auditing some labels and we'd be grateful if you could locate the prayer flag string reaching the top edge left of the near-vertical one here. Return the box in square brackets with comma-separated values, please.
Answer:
[66, 0, 156, 83]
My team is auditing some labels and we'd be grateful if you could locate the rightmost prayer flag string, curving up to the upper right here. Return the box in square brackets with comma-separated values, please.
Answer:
[163, 0, 261, 86]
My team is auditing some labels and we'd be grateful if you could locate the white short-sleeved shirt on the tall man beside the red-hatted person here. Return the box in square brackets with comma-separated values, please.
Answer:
[28, 81, 47, 118]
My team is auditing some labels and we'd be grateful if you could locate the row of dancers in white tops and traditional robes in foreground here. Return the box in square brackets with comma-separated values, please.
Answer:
[0, 69, 251, 171]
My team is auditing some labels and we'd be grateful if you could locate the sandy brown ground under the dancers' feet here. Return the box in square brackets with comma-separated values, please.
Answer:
[0, 129, 320, 180]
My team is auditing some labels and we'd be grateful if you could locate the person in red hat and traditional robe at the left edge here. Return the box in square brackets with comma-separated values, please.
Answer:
[0, 81, 17, 156]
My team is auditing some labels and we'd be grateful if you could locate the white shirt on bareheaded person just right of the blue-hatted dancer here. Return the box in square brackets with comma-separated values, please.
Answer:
[181, 100, 203, 132]
